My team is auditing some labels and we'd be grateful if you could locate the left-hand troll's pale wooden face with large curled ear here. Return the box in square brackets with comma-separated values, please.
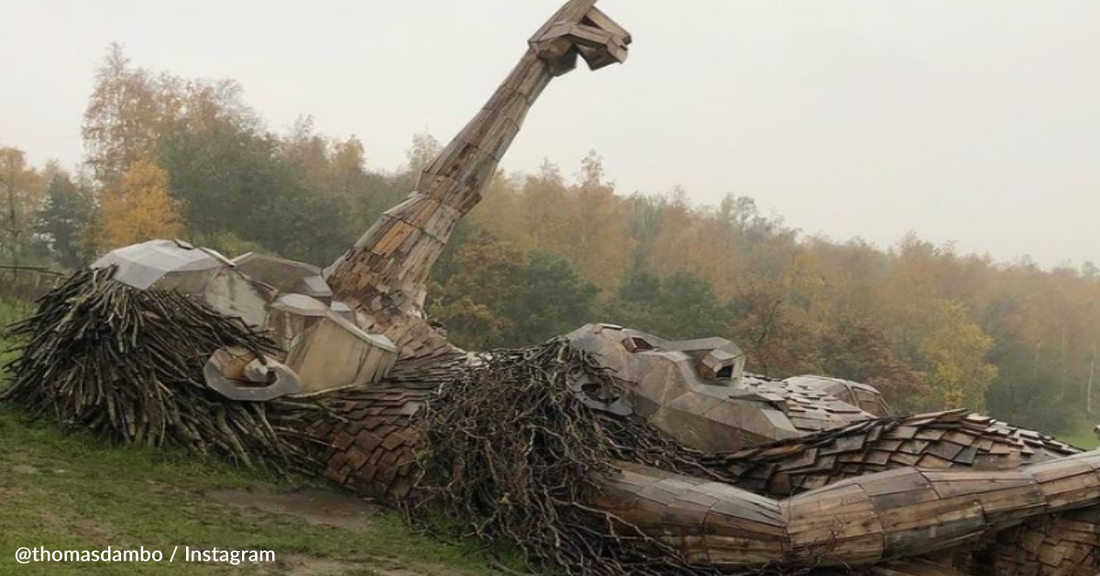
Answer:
[92, 240, 397, 400]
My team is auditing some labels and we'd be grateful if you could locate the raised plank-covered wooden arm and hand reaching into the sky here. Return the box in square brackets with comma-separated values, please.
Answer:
[327, 0, 631, 318]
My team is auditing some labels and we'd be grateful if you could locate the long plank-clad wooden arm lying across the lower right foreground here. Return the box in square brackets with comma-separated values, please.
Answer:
[595, 452, 1100, 567]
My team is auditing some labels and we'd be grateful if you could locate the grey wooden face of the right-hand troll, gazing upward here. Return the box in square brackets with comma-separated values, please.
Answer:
[568, 324, 870, 452]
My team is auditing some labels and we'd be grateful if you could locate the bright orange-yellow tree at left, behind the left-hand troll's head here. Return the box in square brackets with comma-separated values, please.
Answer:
[98, 159, 184, 250]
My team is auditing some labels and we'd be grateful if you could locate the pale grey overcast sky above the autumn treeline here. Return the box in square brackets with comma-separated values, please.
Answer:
[0, 0, 1100, 265]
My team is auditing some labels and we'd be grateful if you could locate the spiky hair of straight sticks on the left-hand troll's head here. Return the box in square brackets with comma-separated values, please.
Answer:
[0, 268, 318, 469]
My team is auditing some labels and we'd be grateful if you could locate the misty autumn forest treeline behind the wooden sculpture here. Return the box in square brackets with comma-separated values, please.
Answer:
[0, 46, 1100, 431]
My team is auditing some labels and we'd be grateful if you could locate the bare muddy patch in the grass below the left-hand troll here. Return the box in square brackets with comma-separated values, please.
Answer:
[207, 487, 381, 529]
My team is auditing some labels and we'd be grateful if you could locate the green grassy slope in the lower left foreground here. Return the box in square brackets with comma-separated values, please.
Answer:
[0, 302, 491, 576]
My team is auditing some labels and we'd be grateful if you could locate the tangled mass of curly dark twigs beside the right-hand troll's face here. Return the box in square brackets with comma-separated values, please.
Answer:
[408, 339, 739, 575]
